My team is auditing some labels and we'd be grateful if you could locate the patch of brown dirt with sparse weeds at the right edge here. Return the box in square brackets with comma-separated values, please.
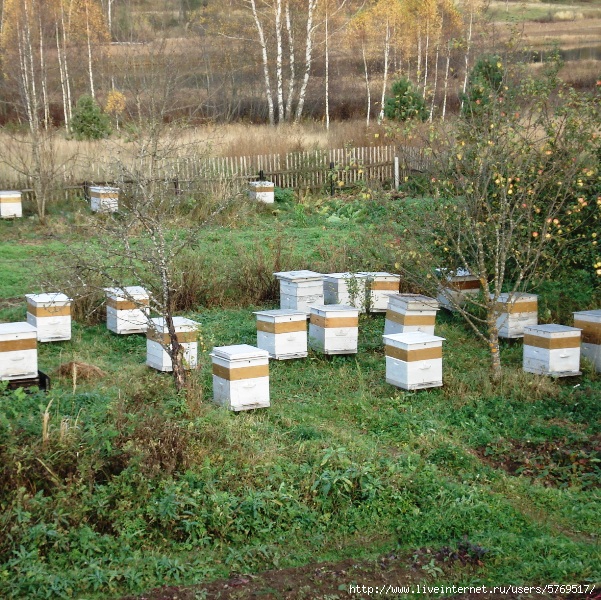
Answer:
[477, 434, 601, 488]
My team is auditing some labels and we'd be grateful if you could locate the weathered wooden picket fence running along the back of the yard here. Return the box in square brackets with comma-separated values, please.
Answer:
[0, 145, 430, 200]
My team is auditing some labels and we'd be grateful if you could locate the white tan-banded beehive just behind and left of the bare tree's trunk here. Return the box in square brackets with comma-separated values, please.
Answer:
[105, 285, 150, 335]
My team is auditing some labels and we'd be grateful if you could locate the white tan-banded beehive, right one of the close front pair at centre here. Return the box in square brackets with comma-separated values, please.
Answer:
[309, 304, 359, 354]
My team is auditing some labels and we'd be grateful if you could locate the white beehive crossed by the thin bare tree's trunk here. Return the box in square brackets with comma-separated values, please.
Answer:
[146, 317, 199, 371]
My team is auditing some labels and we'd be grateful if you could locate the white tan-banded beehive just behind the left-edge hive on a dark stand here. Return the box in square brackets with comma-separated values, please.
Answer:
[25, 293, 71, 342]
